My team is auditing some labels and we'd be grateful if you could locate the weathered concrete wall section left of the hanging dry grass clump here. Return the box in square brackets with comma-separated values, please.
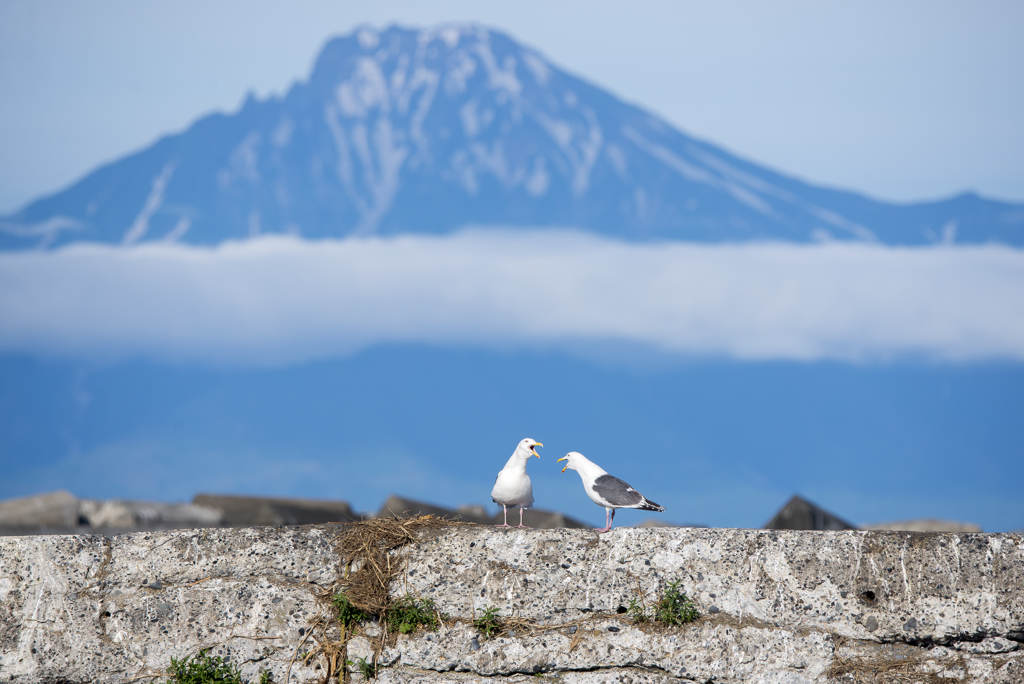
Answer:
[0, 527, 338, 682]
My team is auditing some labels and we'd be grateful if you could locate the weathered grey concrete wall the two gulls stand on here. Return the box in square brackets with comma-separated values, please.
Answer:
[0, 526, 1024, 684]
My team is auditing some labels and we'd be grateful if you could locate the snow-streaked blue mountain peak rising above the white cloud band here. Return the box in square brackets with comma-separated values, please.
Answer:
[0, 27, 1024, 249]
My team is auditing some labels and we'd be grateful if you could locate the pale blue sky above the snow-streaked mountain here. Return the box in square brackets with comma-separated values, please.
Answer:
[6, 0, 1024, 212]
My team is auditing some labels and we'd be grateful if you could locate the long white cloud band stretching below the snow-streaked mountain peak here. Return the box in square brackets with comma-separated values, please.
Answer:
[0, 231, 1024, 364]
